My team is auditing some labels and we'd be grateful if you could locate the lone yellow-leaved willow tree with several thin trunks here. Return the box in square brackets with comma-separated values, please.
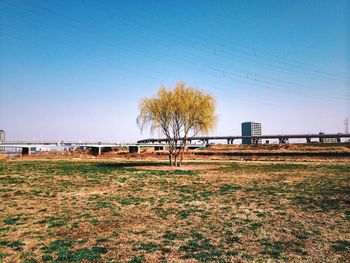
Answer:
[137, 82, 216, 166]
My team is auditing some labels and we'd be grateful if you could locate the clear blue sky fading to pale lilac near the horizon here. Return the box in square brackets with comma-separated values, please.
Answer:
[0, 0, 350, 142]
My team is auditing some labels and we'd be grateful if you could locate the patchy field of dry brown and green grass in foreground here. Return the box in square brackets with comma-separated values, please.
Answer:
[0, 160, 350, 262]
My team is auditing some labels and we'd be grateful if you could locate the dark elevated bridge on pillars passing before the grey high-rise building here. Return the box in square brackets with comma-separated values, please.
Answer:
[137, 133, 350, 145]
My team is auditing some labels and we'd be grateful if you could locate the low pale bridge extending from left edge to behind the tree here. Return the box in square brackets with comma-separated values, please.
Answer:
[0, 141, 205, 155]
